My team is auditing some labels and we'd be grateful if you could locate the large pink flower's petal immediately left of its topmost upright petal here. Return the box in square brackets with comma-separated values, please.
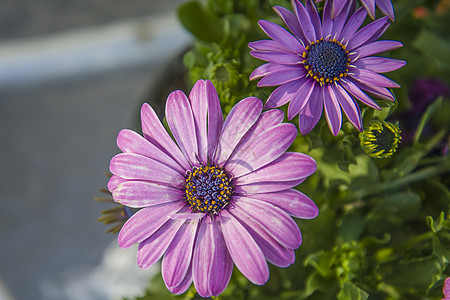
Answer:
[166, 90, 198, 165]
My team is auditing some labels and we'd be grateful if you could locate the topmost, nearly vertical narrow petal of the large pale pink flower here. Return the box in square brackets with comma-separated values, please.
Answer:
[189, 80, 209, 165]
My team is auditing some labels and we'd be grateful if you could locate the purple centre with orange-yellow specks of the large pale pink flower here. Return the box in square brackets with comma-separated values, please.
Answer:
[185, 166, 233, 214]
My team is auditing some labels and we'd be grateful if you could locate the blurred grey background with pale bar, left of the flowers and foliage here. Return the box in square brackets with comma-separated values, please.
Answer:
[0, 0, 190, 300]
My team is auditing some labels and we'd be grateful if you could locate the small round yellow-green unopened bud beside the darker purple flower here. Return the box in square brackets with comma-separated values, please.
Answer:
[359, 120, 402, 158]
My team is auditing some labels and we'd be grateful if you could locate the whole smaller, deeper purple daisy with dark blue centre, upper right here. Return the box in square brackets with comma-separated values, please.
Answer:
[249, 0, 406, 135]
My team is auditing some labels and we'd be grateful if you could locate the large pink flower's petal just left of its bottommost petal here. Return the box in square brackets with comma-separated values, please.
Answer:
[161, 220, 198, 287]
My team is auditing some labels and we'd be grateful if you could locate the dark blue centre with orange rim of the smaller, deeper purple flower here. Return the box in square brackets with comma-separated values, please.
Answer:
[302, 38, 351, 84]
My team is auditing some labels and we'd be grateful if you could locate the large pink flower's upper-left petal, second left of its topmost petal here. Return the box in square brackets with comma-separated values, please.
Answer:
[141, 103, 190, 170]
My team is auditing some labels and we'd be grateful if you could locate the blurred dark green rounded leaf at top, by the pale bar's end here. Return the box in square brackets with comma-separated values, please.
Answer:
[177, 1, 226, 43]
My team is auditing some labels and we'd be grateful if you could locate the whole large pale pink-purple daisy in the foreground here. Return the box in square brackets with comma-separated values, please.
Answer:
[108, 80, 318, 297]
